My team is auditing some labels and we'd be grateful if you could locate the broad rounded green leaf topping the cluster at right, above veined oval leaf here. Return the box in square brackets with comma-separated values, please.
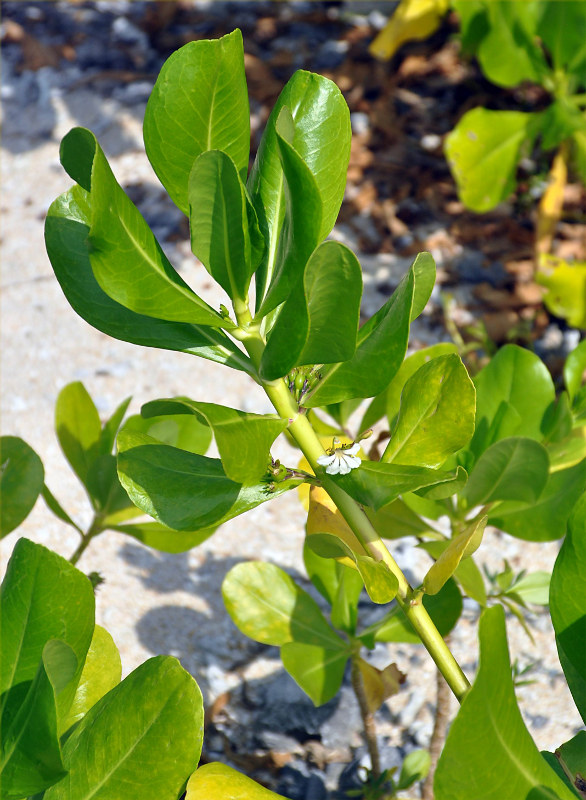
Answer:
[470, 344, 555, 457]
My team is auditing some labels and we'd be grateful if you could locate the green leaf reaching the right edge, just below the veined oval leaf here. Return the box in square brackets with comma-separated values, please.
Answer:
[488, 460, 586, 542]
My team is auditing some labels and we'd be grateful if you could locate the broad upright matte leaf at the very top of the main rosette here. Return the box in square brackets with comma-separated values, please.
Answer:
[144, 30, 250, 214]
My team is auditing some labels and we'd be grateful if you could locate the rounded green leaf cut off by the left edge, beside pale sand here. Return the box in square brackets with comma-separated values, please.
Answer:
[0, 436, 45, 538]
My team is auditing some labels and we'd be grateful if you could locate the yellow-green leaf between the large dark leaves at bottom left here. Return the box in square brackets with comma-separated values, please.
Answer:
[59, 625, 122, 733]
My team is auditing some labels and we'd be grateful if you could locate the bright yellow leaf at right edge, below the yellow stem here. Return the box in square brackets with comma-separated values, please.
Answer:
[536, 254, 586, 328]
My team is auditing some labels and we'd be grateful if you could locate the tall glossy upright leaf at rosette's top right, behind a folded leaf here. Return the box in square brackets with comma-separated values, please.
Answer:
[248, 70, 351, 309]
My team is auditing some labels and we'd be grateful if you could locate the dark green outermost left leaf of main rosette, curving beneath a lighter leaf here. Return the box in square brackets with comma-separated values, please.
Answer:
[45, 186, 249, 373]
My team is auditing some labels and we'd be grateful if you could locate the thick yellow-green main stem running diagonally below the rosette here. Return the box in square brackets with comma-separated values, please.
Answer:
[238, 313, 470, 701]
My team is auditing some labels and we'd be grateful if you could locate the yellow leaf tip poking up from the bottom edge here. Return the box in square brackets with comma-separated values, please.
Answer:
[185, 761, 283, 800]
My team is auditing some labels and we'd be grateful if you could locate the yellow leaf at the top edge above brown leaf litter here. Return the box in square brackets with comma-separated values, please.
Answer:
[370, 0, 449, 61]
